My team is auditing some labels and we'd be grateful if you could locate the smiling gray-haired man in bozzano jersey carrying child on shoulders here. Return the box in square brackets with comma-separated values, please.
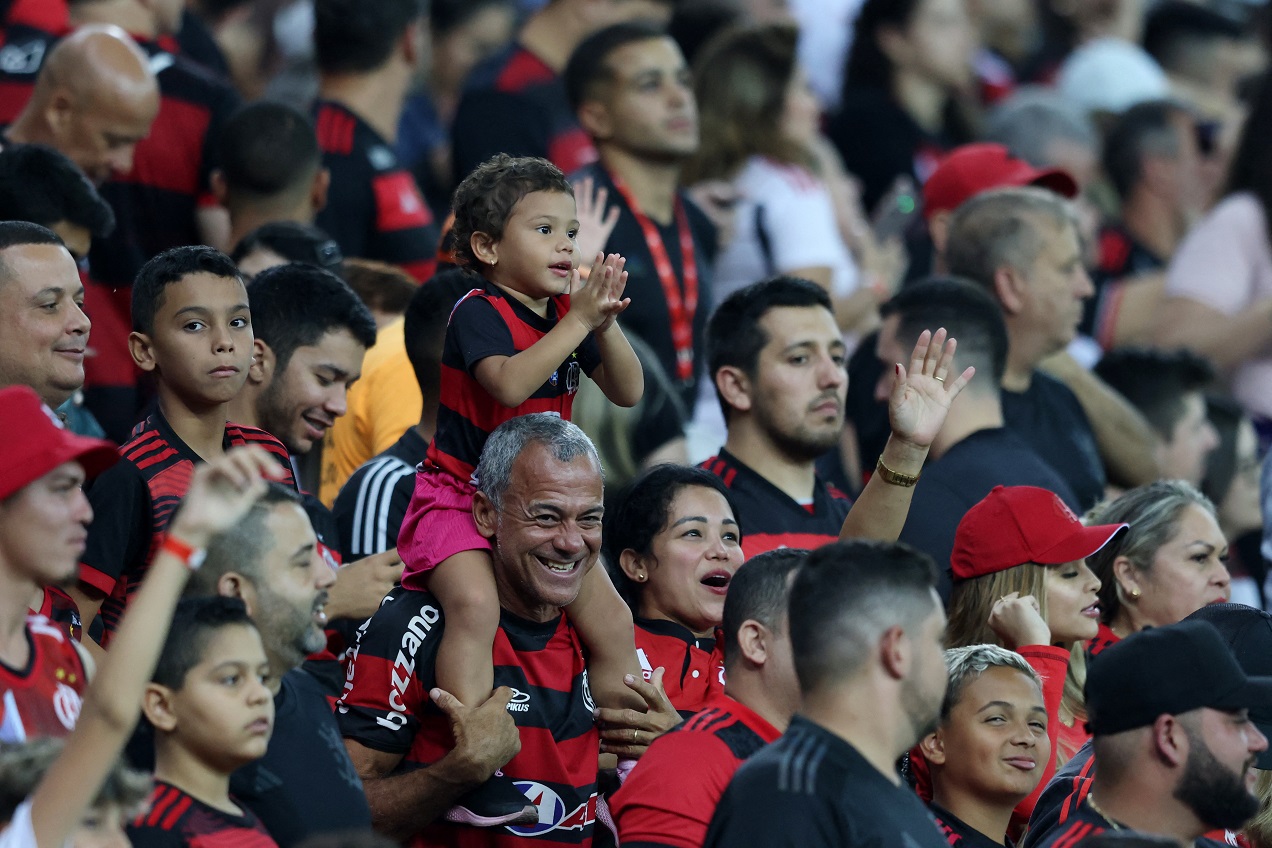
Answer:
[338, 413, 647, 845]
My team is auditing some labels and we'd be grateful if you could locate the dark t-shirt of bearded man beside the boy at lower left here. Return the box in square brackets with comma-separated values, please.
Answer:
[230, 669, 371, 848]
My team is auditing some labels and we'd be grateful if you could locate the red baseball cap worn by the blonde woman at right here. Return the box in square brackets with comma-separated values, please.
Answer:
[950, 486, 1131, 580]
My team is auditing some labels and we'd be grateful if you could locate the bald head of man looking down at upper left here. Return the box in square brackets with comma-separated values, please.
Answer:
[5, 24, 159, 186]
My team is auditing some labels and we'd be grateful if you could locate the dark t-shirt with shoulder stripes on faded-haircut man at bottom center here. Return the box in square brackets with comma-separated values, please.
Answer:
[706, 716, 949, 848]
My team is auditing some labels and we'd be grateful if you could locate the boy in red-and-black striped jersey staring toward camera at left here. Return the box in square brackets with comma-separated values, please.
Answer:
[69, 245, 295, 647]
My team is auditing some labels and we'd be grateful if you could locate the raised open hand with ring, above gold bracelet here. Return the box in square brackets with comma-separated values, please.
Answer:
[888, 327, 976, 448]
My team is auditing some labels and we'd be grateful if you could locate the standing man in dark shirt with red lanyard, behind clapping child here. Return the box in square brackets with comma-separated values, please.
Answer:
[565, 22, 716, 409]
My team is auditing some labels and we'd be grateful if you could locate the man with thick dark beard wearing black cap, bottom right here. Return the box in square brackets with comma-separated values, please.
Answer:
[1030, 620, 1272, 848]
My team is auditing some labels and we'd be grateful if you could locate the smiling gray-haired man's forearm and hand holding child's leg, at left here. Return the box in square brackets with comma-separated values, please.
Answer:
[345, 687, 522, 840]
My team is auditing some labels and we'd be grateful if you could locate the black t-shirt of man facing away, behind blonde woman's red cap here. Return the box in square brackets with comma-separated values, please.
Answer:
[901, 427, 1080, 601]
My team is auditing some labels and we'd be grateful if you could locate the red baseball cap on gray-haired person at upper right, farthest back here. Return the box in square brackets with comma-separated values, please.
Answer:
[923, 142, 1077, 219]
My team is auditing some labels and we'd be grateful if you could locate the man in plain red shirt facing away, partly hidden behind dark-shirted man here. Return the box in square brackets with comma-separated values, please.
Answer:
[609, 548, 808, 848]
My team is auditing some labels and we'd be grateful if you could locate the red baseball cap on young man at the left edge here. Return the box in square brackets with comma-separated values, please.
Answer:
[0, 385, 120, 500]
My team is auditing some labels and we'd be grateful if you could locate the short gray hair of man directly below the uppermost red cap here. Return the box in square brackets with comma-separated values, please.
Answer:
[945, 186, 1077, 294]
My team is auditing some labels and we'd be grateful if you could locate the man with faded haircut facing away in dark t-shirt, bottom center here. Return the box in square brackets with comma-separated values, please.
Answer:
[705, 542, 946, 848]
